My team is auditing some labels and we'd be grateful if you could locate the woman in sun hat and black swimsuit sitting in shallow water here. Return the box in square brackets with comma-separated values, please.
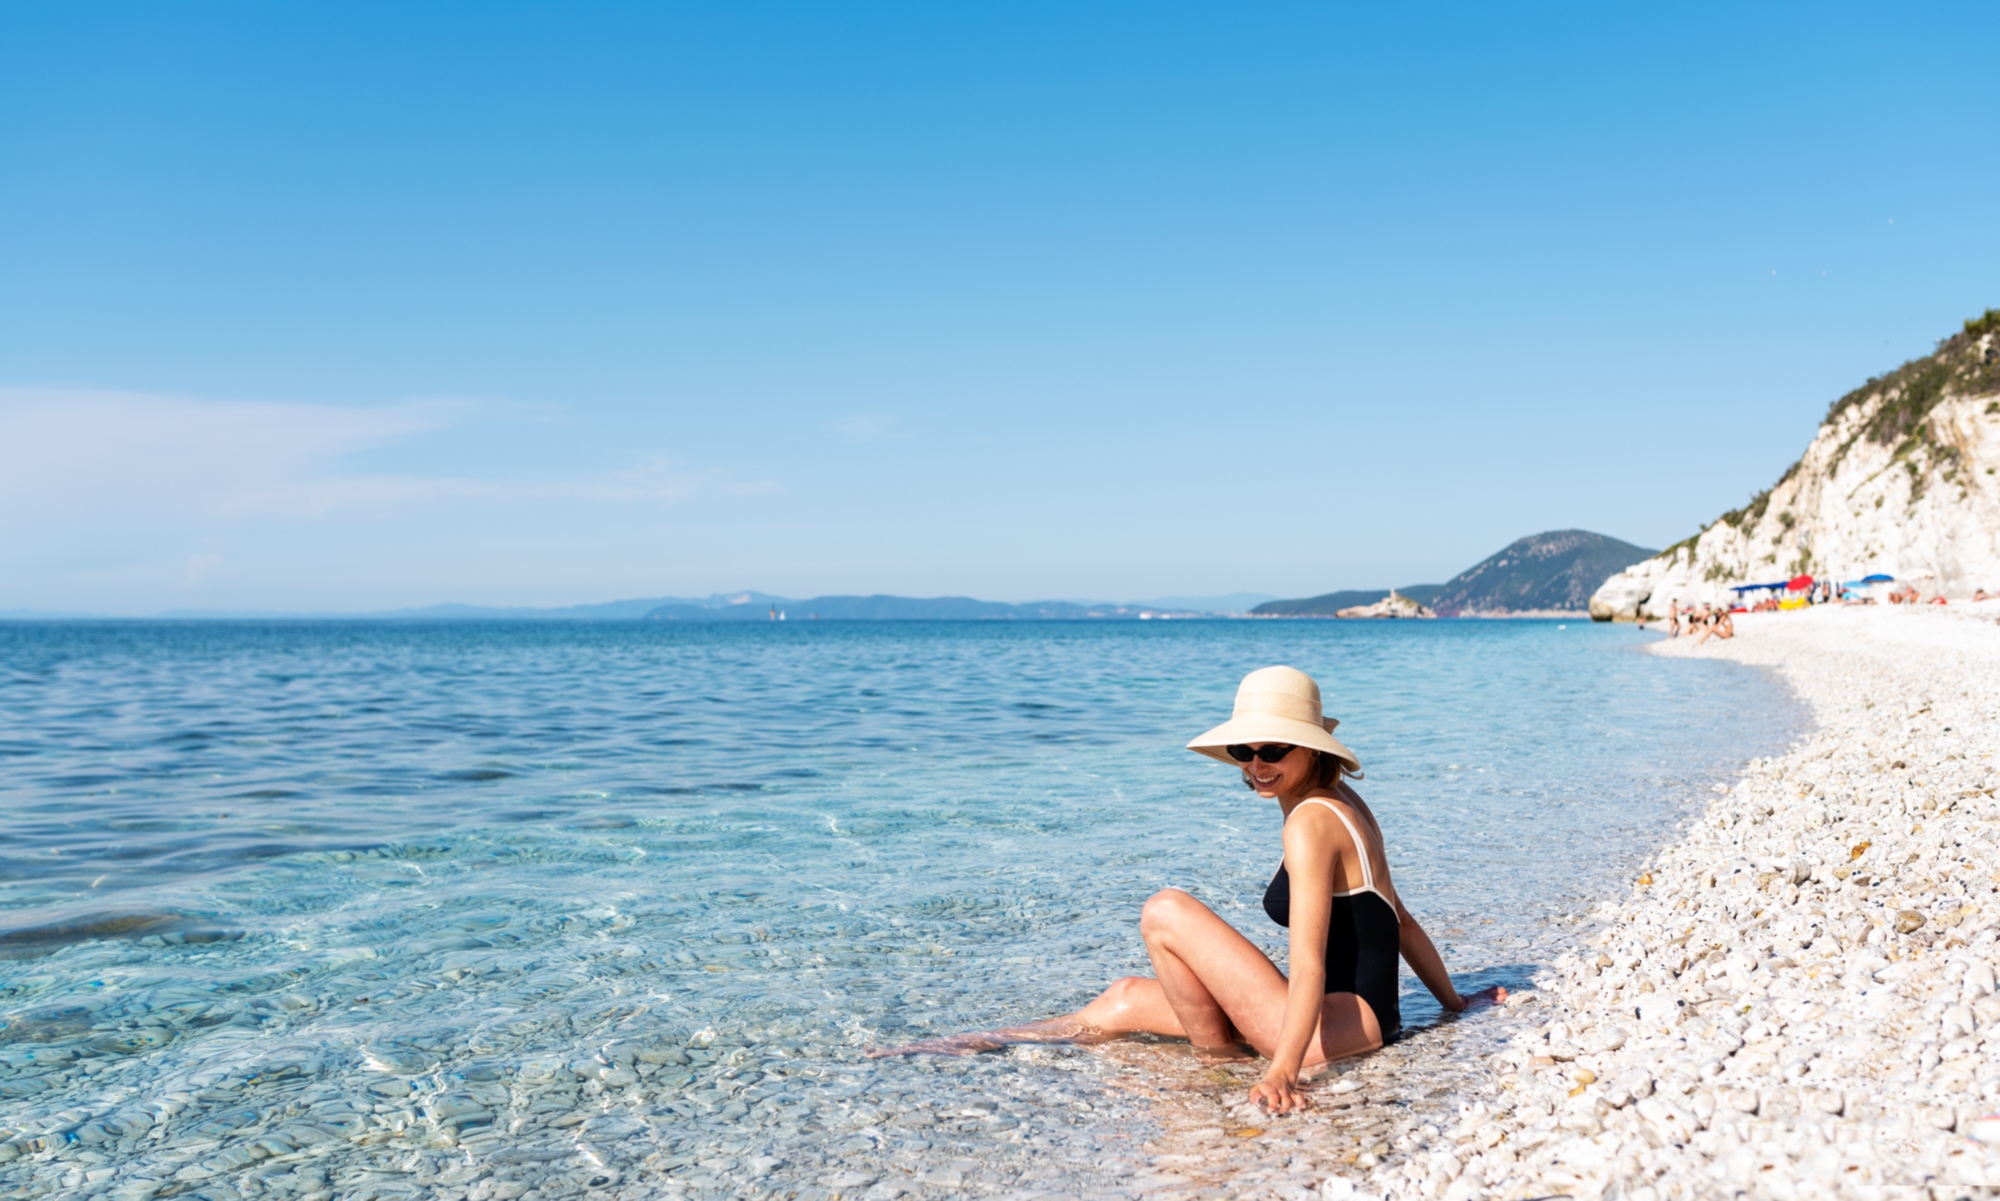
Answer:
[874, 667, 1506, 1113]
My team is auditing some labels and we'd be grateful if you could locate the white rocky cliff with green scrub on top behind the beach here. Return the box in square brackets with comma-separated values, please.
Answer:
[1590, 310, 2000, 621]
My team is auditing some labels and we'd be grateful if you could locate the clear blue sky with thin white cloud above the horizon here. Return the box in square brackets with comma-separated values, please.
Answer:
[0, 4, 2000, 613]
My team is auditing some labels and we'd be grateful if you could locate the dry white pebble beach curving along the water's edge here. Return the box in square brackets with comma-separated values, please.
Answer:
[1322, 605, 2000, 1201]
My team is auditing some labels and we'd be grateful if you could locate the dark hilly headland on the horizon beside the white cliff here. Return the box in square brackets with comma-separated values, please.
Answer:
[1250, 530, 1656, 617]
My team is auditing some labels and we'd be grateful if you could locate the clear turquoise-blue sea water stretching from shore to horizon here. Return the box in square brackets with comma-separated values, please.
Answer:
[0, 621, 1796, 1197]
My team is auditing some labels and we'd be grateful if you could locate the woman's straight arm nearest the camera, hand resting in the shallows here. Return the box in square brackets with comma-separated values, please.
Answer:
[1250, 805, 1336, 1113]
